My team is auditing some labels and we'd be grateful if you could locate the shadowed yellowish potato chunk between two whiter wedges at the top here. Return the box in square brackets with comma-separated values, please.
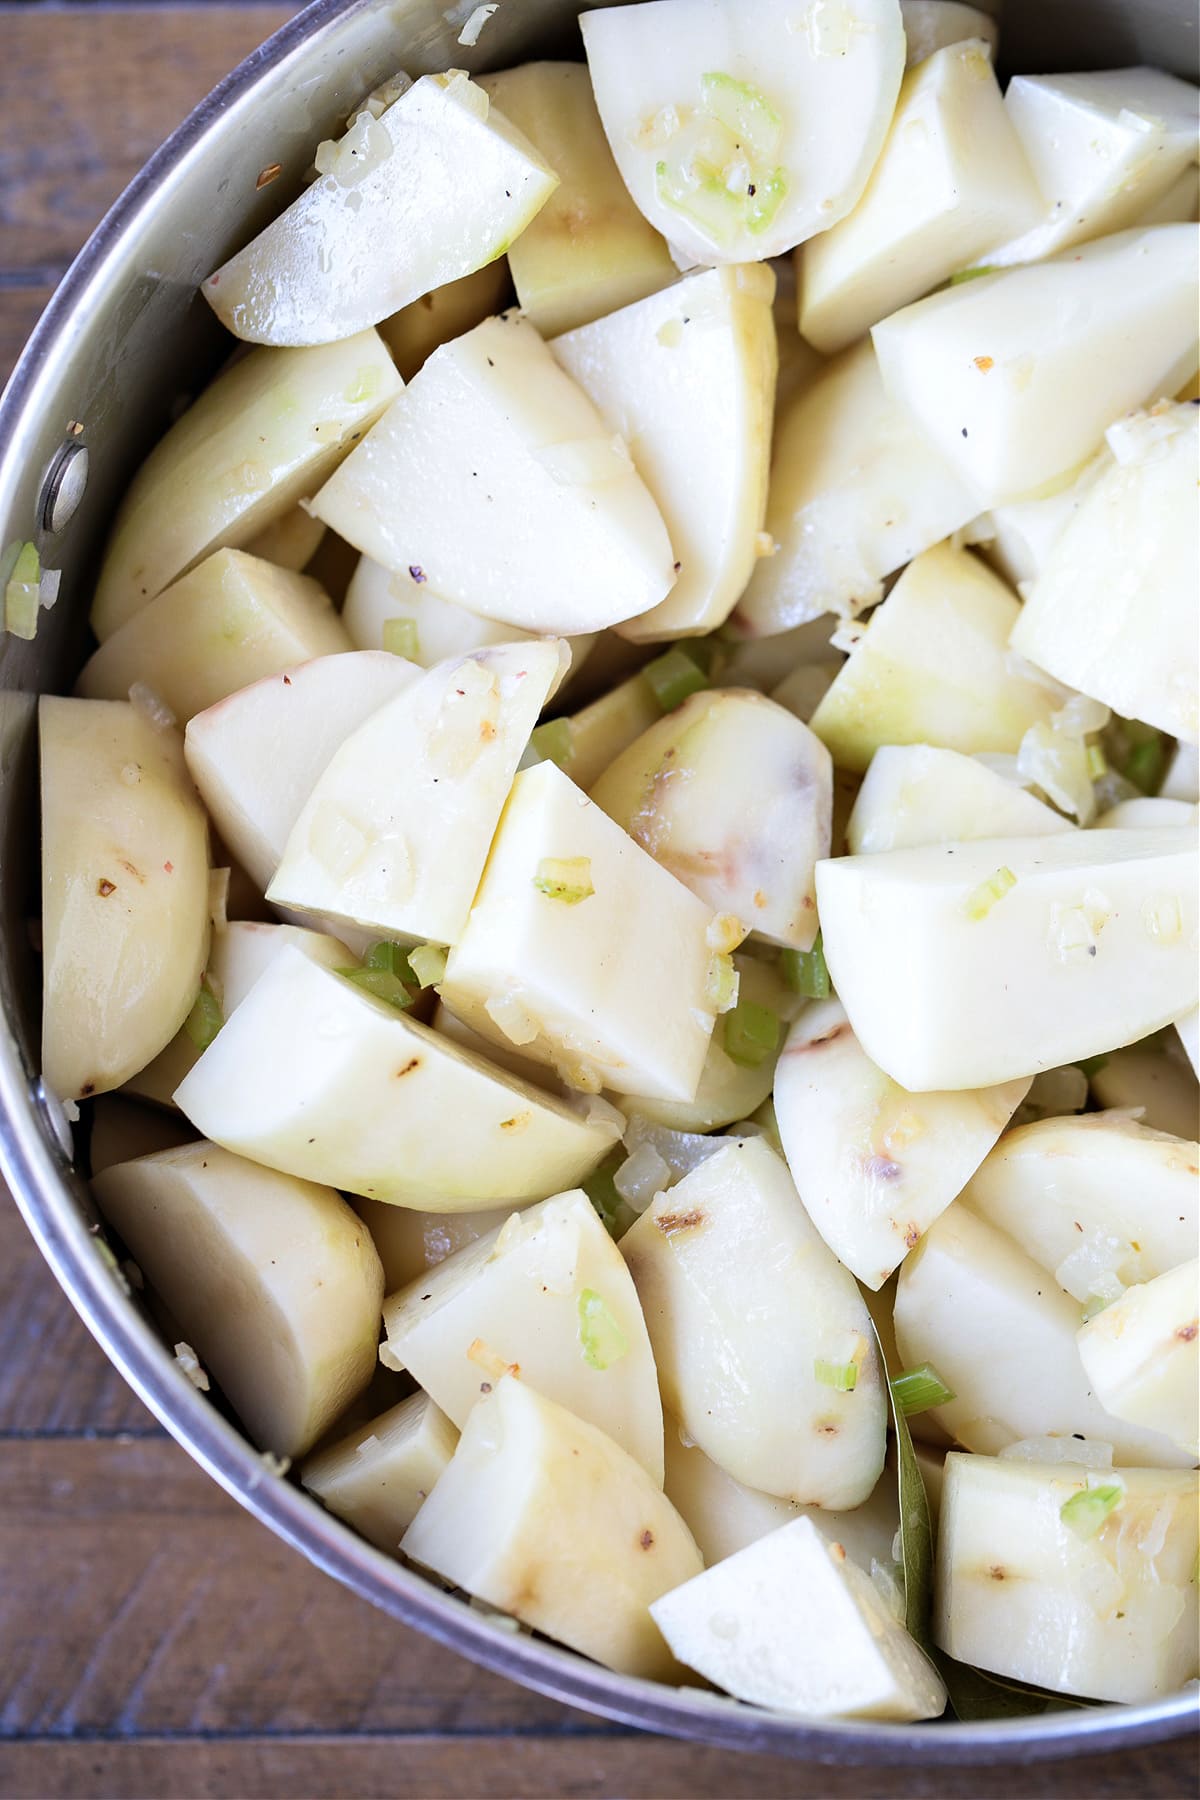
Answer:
[479, 63, 676, 337]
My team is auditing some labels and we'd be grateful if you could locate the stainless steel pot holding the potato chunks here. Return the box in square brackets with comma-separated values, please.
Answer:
[0, 0, 1196, 1764]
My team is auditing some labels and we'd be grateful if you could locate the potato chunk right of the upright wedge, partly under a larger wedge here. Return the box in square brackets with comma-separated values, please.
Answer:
[730, 342, 979, 630]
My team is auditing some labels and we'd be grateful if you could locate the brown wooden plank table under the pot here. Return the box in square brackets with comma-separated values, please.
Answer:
[0, 0, 1195, 1800]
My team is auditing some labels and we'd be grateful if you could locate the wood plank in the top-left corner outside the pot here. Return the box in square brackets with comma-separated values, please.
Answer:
[0, 5, 299, 274]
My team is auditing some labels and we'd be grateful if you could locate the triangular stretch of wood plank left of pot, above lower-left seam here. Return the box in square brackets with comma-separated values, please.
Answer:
[0, 1195, 160, 1432]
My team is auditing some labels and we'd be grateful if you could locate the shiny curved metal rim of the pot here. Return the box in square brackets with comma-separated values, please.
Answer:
[0, 0, 1198, 1766]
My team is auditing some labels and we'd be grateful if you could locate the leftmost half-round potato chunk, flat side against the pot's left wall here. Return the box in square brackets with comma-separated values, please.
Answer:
[38, 695, 209, 1100]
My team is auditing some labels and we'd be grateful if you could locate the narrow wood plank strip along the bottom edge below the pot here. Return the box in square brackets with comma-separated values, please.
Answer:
[0, 1732, 1195, 1800]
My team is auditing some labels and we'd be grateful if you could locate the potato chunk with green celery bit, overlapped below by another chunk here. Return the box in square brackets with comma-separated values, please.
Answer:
[380, 1190, 662, 1485]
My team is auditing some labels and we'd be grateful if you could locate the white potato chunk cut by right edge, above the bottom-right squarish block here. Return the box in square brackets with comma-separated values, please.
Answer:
[1076, 1256, 1200, 1462]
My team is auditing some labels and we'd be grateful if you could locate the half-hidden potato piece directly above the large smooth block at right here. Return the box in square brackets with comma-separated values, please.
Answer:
[846, 743, 1074, 857]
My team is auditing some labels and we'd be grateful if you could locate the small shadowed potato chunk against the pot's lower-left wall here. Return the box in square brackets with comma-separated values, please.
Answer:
[300, 1393, 459, 1555]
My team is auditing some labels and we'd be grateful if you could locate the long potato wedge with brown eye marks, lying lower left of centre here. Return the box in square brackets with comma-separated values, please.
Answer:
[175, 949, 621, 1213]
